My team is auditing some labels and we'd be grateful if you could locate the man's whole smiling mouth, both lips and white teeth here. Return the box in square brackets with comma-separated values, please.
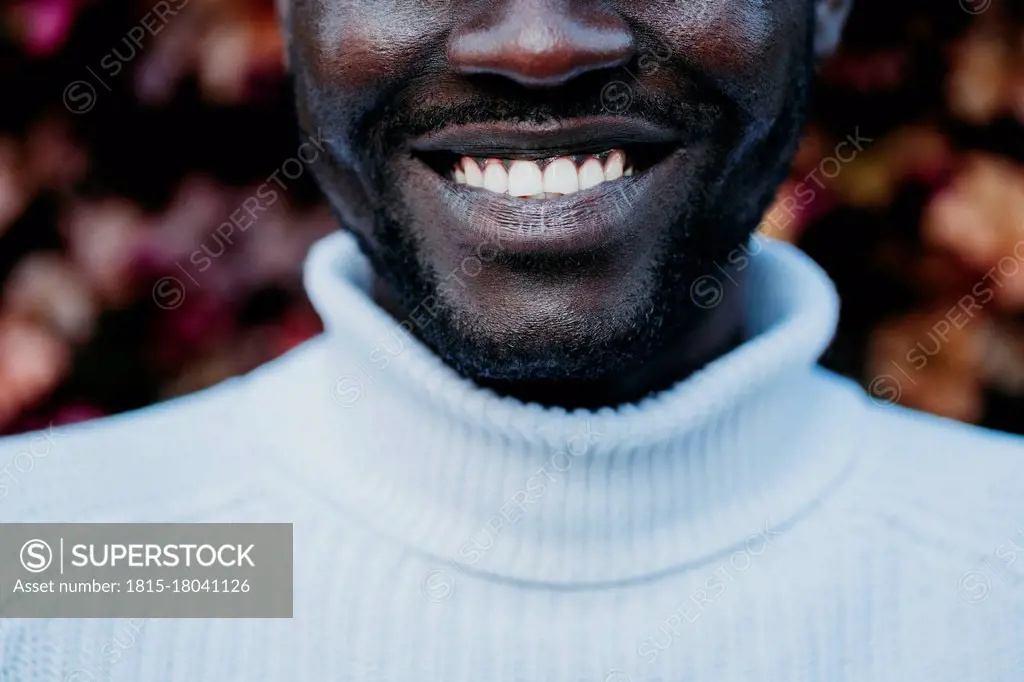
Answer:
[399, 117, 702, 256]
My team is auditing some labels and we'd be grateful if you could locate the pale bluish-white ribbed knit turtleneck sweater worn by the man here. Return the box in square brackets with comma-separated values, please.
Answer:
[0, 232, 1024, 682]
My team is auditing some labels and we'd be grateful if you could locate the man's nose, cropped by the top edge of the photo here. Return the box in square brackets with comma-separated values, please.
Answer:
[449, 0, 634, 87]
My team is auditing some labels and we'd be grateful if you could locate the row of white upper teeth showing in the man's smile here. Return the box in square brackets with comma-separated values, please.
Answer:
[453, 150, 634, 199]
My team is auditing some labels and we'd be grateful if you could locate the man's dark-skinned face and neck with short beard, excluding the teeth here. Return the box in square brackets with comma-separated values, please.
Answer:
[282, 0, 849, 408]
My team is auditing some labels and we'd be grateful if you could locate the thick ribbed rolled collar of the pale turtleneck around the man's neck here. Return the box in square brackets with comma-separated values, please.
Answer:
[293, 232, 852, 586]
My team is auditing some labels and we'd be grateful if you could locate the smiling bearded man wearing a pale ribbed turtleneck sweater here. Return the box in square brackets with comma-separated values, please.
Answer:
[0, 0, 1024, 682]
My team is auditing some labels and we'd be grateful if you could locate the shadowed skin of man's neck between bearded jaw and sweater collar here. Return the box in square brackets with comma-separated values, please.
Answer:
[373, 269, 745, 403]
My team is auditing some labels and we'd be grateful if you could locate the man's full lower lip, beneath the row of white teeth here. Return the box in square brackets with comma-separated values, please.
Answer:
[410, 150, 684, 255]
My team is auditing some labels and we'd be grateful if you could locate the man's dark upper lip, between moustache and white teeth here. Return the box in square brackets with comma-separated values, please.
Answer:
[412, 117, 682, 159]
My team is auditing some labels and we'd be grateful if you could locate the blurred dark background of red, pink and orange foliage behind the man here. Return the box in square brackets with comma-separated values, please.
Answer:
[0, 0, 1024, 433]
